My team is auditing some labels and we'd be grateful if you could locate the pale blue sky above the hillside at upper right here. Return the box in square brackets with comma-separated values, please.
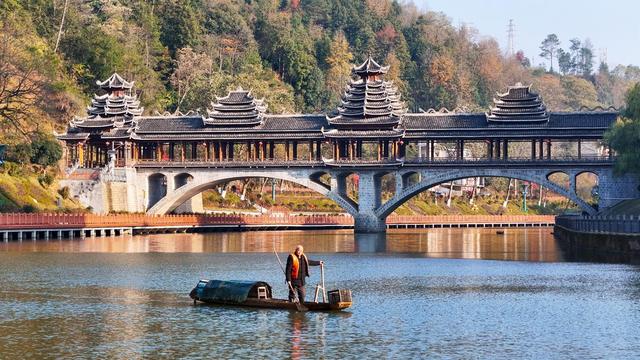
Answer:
[413, 0, 640, 69]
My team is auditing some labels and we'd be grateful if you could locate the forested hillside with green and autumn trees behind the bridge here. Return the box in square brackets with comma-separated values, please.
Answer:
[0, 0, 640, 143]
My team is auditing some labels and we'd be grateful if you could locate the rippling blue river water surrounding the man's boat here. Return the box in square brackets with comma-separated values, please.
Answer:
[0, 229, 640, 359]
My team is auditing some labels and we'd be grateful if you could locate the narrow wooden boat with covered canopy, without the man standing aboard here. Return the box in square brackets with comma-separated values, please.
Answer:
[189, 280, 351, 311]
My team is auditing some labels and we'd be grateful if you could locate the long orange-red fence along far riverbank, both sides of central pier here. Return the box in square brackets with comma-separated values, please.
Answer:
[0, 213, 554, 230]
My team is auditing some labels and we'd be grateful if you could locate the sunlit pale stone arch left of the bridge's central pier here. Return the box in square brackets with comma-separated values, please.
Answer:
[147, 170, 358, 216]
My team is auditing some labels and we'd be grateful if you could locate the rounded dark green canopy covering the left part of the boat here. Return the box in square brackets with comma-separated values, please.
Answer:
[194, 280, 271, 304]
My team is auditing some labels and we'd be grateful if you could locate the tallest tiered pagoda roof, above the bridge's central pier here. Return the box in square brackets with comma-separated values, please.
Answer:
[325, 56, 405, 137]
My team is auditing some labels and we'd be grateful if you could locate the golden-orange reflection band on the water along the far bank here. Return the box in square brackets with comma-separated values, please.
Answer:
[0, 228, 562, 261]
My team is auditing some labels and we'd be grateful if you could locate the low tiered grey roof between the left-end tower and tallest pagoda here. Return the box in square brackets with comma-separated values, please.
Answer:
[205, 87, 267, 126]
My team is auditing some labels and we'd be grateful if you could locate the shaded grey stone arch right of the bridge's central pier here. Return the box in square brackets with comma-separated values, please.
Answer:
[375, 168, 596, 219]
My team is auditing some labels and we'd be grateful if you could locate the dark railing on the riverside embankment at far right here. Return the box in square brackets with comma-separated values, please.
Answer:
[556, 215, 640, 235]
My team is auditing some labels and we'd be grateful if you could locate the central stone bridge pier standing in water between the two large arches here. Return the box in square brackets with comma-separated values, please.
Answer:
[353, 171, 387, 233]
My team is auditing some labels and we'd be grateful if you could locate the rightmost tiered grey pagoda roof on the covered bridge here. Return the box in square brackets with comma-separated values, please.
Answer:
[486, 83, 549, 123]
